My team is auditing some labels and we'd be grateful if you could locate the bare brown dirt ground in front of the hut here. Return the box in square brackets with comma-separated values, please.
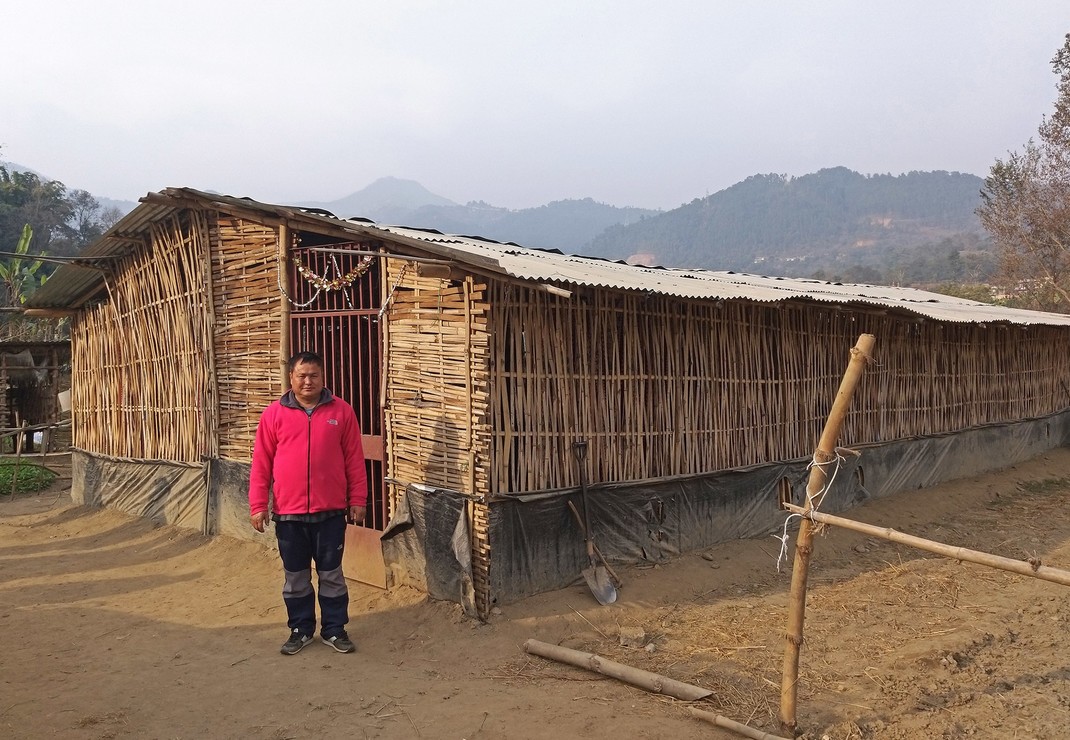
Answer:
[0, 448, 1070, 740]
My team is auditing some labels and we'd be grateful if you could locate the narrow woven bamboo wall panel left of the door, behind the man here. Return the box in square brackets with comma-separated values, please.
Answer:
[212, 215, 286, 462]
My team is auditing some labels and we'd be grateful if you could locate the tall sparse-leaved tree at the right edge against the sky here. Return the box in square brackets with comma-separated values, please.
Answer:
[977, 33, 1070, 313]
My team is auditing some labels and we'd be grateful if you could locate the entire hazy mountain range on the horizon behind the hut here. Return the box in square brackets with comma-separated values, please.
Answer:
[2, 166, 991, 282]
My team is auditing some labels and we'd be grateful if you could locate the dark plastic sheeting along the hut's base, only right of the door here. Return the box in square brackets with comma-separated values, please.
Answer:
[384, 412, 1070, 603]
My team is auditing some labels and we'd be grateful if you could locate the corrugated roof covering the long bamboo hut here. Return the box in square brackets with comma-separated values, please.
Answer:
[27, 188, 1070, 326]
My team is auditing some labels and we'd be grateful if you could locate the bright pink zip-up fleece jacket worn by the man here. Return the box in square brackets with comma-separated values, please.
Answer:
[249, 390, 368, 514]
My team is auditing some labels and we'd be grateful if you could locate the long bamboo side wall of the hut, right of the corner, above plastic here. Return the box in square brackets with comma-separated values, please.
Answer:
[489, 281, 1070, 492]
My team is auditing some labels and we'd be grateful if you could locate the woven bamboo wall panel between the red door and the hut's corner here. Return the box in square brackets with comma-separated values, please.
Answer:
[385, 266, 490, 614]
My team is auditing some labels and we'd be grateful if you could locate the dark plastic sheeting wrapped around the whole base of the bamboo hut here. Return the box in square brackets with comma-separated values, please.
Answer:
[72, 410, 1070, 616]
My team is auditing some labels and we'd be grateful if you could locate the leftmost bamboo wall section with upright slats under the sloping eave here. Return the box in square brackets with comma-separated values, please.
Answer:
[71, 212, 216, 462]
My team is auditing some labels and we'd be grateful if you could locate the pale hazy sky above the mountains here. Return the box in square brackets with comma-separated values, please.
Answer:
[0, 0, 1070, 210]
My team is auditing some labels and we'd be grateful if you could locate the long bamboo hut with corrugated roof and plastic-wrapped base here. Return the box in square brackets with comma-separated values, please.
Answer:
[28, 188, 1070, 615]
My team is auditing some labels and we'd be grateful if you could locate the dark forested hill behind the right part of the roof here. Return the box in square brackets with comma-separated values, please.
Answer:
[585, 167, 984, 275]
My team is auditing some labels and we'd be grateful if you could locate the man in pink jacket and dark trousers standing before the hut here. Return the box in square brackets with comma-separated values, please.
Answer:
[249, 352, 368, 656]
